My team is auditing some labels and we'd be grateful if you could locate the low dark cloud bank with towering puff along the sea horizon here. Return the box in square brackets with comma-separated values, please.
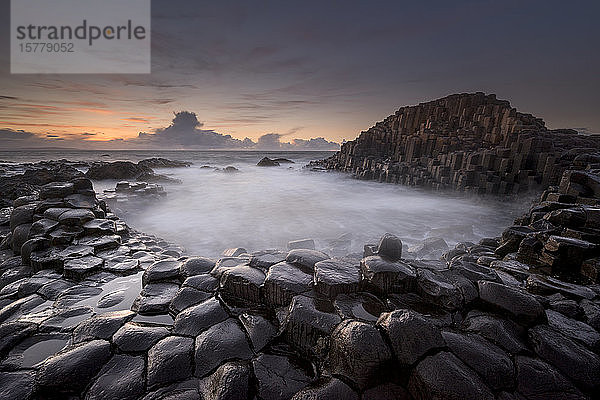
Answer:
[0, 111, 339, 151]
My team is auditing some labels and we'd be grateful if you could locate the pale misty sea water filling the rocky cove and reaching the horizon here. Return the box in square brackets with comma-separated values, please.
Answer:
[0, 149, 531, 257]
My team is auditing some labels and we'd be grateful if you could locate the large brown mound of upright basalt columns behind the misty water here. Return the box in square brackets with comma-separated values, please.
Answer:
[312, 93, 600, 194]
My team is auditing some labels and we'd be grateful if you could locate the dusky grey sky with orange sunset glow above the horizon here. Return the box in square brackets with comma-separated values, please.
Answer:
[0, 0, 600, 149]
